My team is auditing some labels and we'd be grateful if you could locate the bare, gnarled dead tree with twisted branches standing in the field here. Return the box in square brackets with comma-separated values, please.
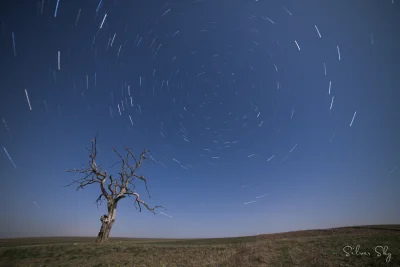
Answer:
[67, 135, 163, 243]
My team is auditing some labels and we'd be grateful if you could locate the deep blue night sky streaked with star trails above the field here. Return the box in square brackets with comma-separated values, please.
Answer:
[0, 0, 400, 237]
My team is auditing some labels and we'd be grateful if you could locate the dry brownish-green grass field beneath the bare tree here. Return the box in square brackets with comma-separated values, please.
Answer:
[0, 225, 400, 267]
